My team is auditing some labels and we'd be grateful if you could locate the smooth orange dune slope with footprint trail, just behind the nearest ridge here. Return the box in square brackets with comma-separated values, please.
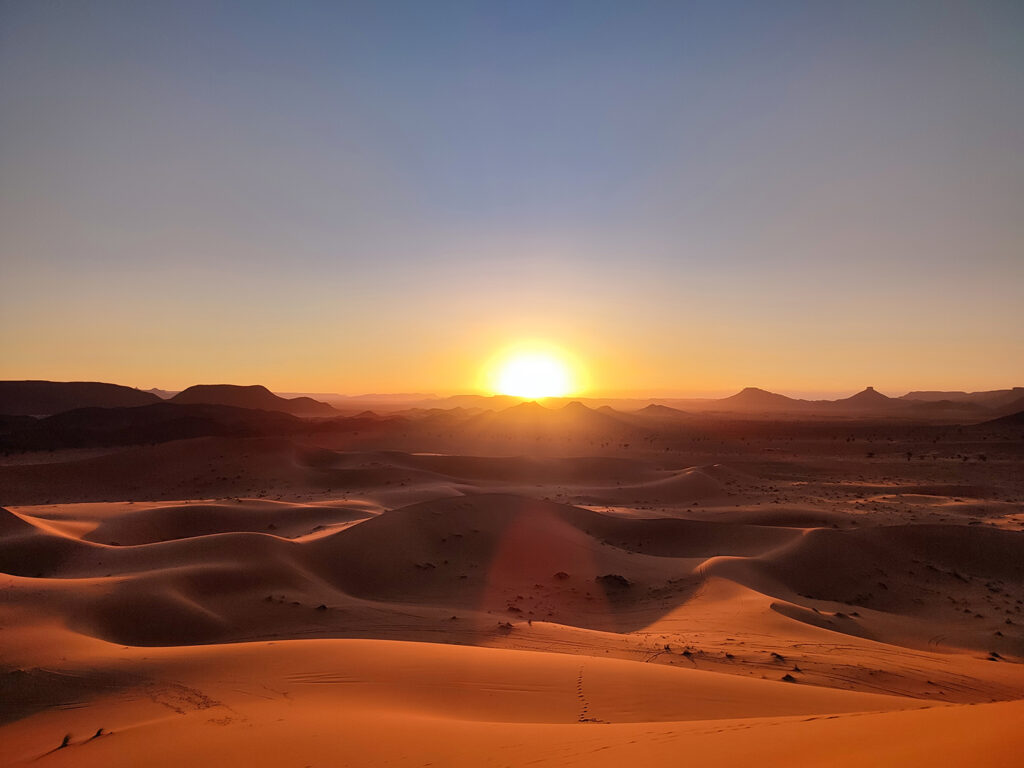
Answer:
[0, 639, 927, 759]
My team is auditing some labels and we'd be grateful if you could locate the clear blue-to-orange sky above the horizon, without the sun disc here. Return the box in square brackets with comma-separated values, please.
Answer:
[0, 0, 1024, 395]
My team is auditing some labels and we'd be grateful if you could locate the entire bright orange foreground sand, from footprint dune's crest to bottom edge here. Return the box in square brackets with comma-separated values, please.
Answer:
[0, 640, 1024, 766]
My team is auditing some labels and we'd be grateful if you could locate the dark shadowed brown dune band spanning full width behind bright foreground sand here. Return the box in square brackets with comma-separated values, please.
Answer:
[0, 494, 1024, 645]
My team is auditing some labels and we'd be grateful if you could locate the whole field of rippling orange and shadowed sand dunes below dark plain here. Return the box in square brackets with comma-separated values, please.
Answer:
[0, 430, 1024, 767]
